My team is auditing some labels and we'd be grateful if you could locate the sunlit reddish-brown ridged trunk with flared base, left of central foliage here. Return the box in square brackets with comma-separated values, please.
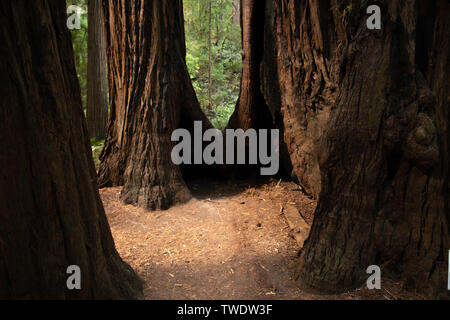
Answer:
[99, 0, 212, 209]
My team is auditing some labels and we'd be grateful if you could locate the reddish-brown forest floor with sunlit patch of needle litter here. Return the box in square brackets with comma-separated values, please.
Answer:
[100, 180, 421, 300]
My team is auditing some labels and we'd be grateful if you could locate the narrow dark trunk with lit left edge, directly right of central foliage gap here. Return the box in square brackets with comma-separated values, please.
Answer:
[227, 0, 292, 177]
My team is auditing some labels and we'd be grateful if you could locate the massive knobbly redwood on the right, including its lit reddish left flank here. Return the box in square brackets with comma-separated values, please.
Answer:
[263, 0, 450, 297]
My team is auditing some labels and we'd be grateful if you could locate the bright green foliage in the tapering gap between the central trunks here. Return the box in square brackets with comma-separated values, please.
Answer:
[183, 0, 242, 129]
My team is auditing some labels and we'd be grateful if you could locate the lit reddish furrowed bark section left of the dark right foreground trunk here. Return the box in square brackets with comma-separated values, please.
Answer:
[262, 1, 340, 198]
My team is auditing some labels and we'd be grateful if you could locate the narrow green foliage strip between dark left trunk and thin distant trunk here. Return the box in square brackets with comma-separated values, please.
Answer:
[66, 0, 88, 110]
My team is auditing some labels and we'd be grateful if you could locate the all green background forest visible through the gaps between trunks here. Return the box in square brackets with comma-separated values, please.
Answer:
[67, 0, 242, 130]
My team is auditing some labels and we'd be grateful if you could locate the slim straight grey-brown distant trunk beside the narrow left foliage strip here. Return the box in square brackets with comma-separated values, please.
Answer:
[87, 0, 108, 139]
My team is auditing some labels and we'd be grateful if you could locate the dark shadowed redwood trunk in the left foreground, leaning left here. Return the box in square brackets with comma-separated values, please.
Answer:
[0, 0, 140, 299]
